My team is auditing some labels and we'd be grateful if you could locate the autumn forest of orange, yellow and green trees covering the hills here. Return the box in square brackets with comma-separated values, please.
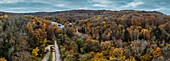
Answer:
[0, 10, 170, 61]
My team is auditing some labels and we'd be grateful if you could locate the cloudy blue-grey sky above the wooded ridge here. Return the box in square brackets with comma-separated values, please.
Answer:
[0, 0, 170, 15]
